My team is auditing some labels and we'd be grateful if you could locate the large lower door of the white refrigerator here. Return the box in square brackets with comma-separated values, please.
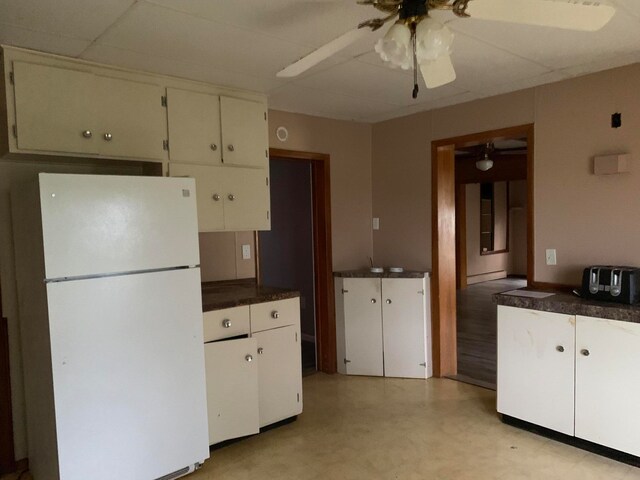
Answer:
[47, 269, 209, 480]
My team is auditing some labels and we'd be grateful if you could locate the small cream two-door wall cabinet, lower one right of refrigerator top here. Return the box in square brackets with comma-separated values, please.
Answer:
[169, 163, 271, 232]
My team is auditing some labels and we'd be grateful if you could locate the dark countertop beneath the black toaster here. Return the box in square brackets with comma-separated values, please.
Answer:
[493, 288, 640, 323]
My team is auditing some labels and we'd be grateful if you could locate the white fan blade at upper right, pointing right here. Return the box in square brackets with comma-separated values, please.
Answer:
[467, 0, 616, 32]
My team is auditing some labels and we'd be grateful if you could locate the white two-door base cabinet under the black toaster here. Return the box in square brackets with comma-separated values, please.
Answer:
[498, 305, 640, 456]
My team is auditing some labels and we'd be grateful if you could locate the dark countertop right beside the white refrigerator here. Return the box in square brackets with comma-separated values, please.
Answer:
[202, 282, 300, 312]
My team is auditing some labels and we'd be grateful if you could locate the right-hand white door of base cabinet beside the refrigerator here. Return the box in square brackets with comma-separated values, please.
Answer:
[252, 325, 302, 427]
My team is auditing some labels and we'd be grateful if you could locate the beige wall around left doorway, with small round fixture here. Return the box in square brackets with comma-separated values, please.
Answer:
[269, 110, 373, 270]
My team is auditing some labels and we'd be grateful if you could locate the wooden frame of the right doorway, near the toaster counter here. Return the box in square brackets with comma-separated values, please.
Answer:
[431, 124, 535, 377]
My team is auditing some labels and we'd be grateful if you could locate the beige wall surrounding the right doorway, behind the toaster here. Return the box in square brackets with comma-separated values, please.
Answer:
[372, 64, 640, 285]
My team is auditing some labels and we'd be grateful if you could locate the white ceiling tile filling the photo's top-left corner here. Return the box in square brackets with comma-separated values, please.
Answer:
[0, 0, 135, 40]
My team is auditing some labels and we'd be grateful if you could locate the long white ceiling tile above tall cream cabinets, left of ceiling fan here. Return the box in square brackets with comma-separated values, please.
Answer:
[98, 3, 316, 77]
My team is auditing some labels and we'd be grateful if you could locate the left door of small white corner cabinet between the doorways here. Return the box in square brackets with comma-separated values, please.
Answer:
[338, 278, 384, 377]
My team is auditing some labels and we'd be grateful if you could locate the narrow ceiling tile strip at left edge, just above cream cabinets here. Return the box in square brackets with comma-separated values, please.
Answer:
[0, 23, 91, 57]
